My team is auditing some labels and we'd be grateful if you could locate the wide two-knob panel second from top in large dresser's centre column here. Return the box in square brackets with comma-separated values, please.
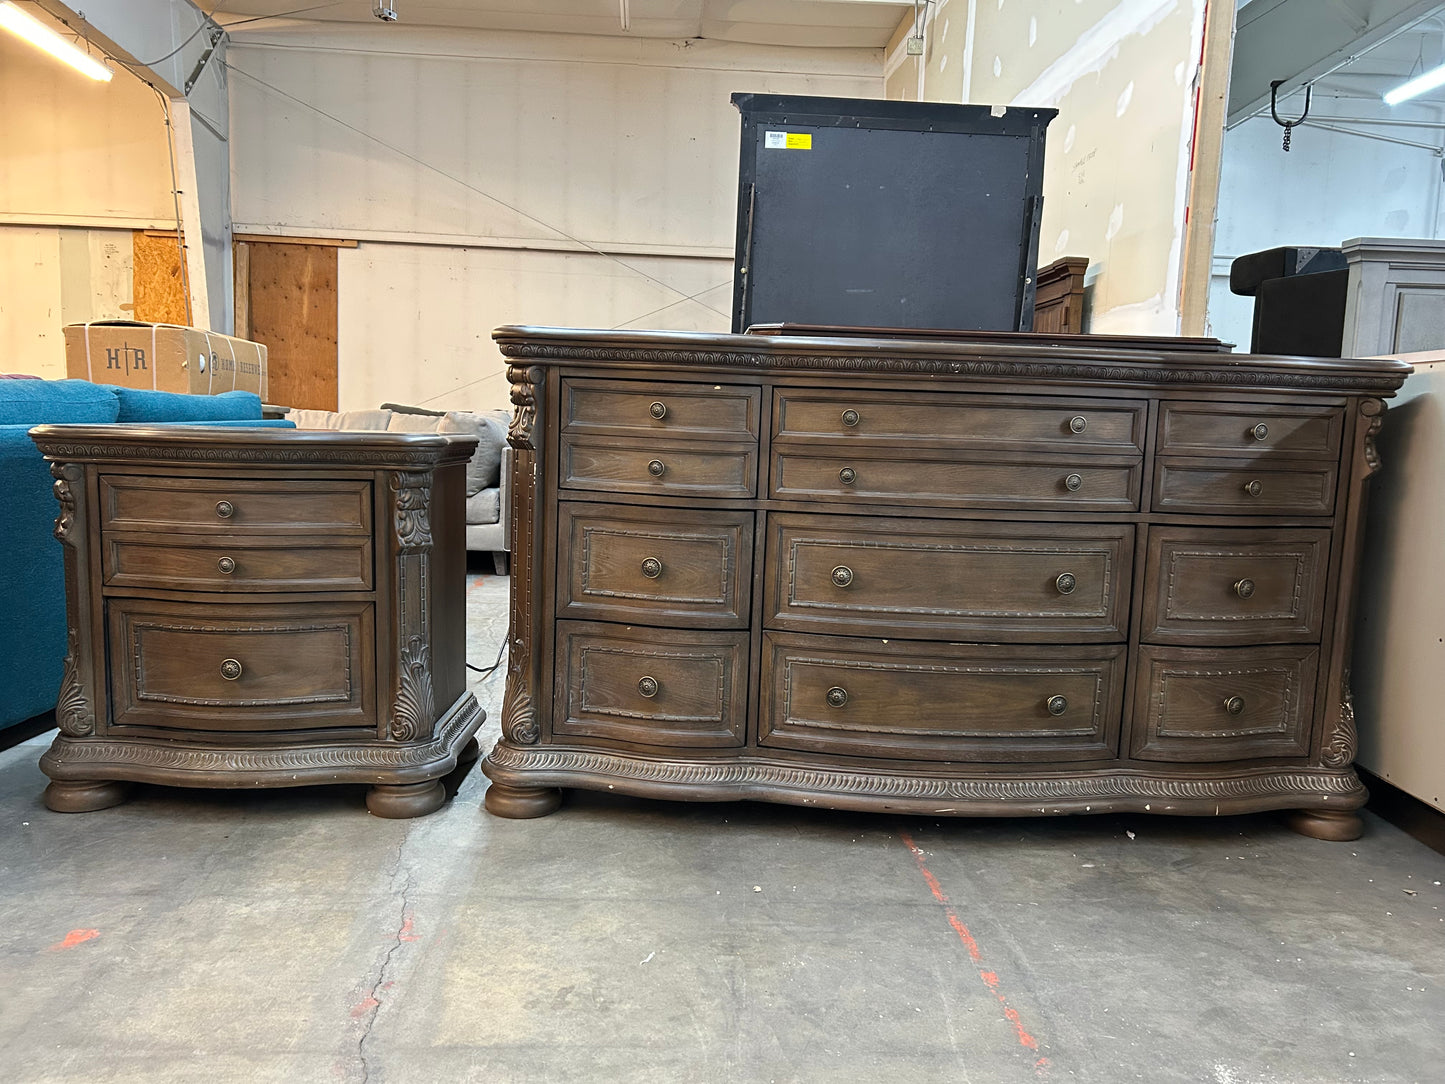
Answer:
[773, 448, 1140, 512]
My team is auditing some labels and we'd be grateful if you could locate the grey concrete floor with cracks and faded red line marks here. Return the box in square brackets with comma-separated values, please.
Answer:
[0, 577, 1445, 1084]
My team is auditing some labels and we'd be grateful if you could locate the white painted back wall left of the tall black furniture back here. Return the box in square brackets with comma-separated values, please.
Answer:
[230, 25, 883, 409]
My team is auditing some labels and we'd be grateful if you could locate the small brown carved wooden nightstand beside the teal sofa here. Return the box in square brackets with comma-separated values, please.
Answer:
[30, 425, 483, 817]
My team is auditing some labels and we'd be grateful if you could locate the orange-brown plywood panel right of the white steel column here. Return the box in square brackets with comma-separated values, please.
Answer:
[247, 241, 339, 410]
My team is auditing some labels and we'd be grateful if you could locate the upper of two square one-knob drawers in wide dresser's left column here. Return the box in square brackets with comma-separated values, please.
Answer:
[556, 502, 753, 629]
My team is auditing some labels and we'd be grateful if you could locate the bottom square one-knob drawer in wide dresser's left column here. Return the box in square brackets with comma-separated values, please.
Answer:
[552, 621, 749, 749]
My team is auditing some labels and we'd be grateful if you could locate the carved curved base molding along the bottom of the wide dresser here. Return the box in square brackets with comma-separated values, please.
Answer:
[481, 741, 1368, 820]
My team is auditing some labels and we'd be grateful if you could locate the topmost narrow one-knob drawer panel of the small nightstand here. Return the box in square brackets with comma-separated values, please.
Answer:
[100, 474, 371, 535]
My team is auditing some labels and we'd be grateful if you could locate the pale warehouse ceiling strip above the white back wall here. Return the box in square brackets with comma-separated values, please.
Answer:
[202, 0, 913, 49]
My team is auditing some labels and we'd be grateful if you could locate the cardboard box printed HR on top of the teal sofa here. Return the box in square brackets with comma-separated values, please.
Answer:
[64, 319, 266, 399]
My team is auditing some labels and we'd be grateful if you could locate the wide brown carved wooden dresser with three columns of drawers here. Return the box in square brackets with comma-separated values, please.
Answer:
[483, 327, 1409, 838]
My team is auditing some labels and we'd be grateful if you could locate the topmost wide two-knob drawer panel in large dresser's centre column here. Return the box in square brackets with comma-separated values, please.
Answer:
[773, 389, 1144, 455]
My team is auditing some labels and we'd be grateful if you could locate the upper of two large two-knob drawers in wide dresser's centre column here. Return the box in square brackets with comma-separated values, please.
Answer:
[766, 513, 1134, 642]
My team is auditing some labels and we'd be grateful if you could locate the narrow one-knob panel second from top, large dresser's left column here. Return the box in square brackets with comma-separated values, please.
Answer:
[558, 436, 757, 497]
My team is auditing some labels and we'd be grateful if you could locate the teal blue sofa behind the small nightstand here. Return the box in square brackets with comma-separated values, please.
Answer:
[0, 380, 295, 746]
